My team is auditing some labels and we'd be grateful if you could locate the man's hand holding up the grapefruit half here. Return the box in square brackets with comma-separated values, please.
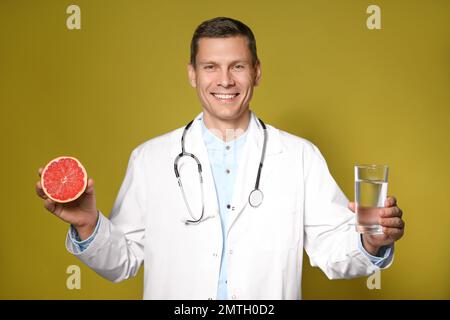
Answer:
[36, 168, 98, 240]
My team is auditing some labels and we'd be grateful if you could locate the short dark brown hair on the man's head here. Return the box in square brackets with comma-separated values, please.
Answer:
[190, 17, 259, 66]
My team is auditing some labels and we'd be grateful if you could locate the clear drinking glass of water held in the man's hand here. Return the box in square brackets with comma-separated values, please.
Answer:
[355, 164, 389, 234]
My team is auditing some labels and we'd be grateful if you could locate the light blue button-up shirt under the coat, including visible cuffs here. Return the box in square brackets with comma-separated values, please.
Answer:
[69, 118, 394, 300]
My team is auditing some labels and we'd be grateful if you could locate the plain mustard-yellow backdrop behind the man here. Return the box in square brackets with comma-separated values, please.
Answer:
[0, 0, 450, 299]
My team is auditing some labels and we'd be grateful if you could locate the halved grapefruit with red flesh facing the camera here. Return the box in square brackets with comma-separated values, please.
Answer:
[41, 156, 87, 203]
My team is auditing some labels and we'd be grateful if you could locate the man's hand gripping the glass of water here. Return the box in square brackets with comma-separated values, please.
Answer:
[348, 196, 405, 256]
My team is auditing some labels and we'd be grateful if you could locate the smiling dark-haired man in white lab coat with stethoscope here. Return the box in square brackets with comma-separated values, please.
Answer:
[37, 18, 404, 299]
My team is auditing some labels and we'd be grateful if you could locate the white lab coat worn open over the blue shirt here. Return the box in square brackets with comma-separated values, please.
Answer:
[66, 113, 392, 299]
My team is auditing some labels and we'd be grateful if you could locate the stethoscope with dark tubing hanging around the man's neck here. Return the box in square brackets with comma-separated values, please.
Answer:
[173, 118, 267, 224]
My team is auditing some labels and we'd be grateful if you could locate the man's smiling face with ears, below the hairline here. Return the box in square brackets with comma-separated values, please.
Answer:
[188, 36, 261, 121]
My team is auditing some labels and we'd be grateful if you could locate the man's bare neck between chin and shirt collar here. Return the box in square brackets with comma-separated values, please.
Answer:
[203, 110, 250, 142]
